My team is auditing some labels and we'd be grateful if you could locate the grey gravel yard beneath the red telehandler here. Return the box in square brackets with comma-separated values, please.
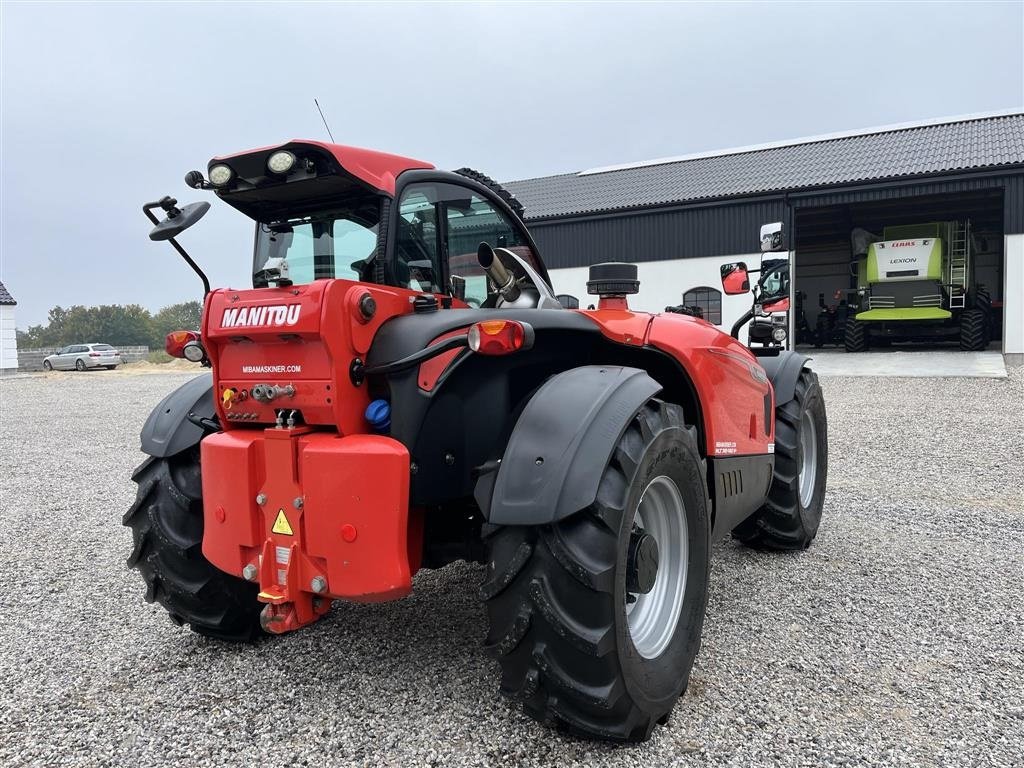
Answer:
[0, 369, 1024, 766]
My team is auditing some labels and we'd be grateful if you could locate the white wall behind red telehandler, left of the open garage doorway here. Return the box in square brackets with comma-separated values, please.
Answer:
[550, 253, 770, 343]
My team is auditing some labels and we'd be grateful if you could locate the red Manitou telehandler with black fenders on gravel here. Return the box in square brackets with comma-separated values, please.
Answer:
[125, 140, 827, 740]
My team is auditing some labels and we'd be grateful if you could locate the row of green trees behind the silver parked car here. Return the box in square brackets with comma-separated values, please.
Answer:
[17, 301, 203, 349]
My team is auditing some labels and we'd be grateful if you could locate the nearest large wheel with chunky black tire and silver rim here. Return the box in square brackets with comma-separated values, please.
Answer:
[481, 400, 710, 741]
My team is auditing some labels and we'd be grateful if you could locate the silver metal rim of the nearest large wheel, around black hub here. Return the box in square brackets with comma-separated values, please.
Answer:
[626, 475, 690, 658]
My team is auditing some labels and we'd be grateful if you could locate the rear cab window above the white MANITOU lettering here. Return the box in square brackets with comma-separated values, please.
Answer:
[253, 206, 380, 288]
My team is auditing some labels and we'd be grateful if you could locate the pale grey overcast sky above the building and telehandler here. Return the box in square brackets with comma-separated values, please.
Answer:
[0, 0, 1024, 329]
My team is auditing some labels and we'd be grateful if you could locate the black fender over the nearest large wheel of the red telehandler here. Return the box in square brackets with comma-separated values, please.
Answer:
[473, 366, 662, 525]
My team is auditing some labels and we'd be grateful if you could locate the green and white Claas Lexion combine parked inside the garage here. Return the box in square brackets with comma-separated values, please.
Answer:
[844, 221, 992, 352]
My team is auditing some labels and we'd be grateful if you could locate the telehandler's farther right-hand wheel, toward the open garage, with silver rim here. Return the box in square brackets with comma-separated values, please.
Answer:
[732, 368, 828, 550]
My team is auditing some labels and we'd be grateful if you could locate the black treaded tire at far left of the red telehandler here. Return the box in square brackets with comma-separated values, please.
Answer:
[124, 449, 263, 642]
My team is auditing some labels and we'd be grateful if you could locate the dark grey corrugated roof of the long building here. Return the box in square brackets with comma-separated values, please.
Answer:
[504, 112, 1024, 220]
